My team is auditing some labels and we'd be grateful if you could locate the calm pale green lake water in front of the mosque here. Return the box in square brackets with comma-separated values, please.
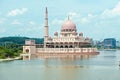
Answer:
[0, 51, 120, 80]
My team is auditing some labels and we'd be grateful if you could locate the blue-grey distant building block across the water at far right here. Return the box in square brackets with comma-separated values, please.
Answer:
[103, 38, 116, 49]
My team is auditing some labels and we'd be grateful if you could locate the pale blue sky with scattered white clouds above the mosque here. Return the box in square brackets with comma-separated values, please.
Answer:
[0, 0, 120, 40]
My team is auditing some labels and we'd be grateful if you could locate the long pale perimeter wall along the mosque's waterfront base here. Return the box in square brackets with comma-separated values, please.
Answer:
[36, 48, 97, 53]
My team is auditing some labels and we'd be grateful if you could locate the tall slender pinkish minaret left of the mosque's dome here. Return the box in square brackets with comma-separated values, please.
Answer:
[44, 7, 49, 47]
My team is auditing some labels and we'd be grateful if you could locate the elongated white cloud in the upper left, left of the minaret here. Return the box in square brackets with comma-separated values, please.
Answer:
[8, 8, 28, 16]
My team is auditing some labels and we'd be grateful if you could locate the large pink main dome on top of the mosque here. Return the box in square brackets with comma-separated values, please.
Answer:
[61, 20, 76, 31]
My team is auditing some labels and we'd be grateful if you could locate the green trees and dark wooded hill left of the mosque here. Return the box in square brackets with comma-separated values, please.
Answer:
[0, 37, 44, 59]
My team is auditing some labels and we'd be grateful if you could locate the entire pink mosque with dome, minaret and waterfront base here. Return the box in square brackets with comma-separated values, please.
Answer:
[22, 8, 98, 59]
